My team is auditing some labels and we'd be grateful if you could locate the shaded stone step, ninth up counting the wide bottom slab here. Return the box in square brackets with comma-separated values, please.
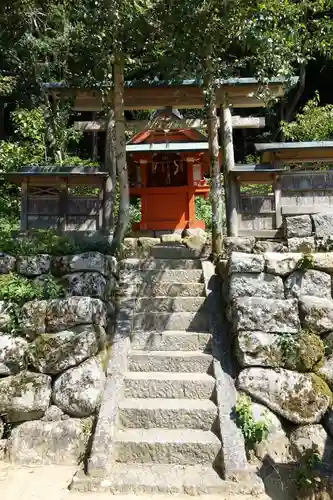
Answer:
[119, 282, 205, 297]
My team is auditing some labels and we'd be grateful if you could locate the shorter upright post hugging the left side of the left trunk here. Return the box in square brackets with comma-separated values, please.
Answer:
[103, 109, 117, 233]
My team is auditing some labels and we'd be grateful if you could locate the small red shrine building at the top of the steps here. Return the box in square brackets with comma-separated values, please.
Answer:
[126, 109, 214, 230]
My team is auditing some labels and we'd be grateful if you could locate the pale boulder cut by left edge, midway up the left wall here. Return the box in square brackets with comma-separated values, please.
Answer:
[0, 334, 28, 376]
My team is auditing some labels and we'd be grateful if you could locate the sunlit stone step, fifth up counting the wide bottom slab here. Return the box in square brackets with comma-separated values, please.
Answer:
[129, 351, 213, 373]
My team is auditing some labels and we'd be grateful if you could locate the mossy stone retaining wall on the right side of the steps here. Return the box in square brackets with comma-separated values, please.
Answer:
[217, 242, 333, 498]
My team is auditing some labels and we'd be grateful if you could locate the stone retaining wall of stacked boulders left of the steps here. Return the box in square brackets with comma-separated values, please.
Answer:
[0, 252, 117, 465]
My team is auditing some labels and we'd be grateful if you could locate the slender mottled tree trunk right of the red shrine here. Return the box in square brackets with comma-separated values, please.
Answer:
[205, 76, 223, 255]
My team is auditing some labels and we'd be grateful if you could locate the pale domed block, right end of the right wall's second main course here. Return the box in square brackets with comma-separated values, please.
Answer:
[285, 269, 332, 299]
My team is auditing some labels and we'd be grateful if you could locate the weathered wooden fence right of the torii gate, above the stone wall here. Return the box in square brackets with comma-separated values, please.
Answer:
[237, 170, 333, 238]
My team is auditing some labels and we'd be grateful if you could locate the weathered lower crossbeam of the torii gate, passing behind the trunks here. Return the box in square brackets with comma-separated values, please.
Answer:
[74, 116, 266, 134]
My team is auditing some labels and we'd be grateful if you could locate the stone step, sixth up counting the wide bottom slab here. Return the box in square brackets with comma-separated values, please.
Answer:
[131, 330, 212, 352]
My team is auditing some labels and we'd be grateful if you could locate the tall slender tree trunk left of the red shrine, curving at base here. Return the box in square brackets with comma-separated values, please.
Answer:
[111, 58, 130, 254]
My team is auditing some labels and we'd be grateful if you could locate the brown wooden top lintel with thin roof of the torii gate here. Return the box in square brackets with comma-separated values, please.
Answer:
[44, 77, 298, 111]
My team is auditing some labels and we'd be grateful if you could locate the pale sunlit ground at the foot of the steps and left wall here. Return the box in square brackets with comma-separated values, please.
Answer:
[0, 463, 270, 500]
